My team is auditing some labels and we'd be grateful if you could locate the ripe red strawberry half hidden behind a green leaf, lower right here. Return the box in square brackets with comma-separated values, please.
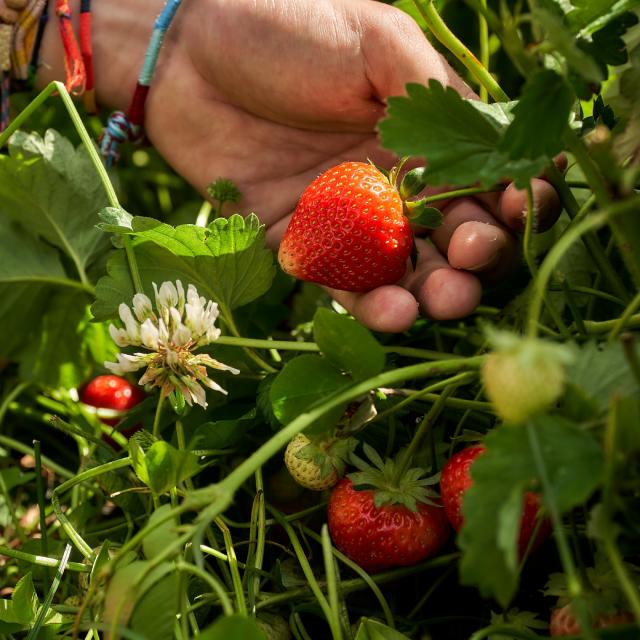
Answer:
[440, 445, 551, 557]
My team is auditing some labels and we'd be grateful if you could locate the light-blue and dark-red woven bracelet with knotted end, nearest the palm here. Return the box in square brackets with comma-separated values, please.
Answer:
[100, 0, 182, 167]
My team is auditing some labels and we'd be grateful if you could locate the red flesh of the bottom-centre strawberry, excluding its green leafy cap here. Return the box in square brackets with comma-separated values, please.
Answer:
[328, 478, 450, 572]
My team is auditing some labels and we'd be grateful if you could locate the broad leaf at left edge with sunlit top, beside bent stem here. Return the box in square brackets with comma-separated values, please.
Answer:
[0, 130, 109, 273]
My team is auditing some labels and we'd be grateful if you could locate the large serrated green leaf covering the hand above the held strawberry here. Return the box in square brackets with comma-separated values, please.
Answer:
[380, 80, 546, 187]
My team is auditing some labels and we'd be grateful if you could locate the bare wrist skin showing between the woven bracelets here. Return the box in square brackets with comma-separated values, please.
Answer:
[36, 0, 164, 109]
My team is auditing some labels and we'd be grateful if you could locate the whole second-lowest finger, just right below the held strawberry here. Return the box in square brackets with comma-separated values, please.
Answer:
[403, 238, 482, 320]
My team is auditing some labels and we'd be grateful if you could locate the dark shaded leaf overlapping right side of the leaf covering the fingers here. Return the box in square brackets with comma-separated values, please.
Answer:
[500, 69, 574, 162]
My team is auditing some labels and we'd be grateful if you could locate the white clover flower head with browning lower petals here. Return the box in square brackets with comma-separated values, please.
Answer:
[105, 280, 240, 408]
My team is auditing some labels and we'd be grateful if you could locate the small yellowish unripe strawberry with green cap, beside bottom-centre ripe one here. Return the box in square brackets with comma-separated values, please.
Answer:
[284, 433, 357, 491]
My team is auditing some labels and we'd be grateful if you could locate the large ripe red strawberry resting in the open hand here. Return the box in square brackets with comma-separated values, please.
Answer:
[278, 162, 413, 291]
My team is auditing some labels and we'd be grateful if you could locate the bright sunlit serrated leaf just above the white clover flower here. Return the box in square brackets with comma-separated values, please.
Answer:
[92, 214, 275, 320]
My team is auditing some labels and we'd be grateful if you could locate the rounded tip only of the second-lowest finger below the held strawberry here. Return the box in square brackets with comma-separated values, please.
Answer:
[419, 267, 482, 320]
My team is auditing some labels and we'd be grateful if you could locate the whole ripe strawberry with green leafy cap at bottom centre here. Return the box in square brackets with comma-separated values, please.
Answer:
[327, 445, 450, 572]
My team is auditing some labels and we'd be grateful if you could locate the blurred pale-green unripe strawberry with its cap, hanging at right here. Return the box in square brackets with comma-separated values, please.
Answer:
[481, 331, 573, 424]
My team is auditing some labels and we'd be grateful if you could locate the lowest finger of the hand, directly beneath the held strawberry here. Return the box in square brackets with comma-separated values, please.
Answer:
[326, 285, 418, 333]
